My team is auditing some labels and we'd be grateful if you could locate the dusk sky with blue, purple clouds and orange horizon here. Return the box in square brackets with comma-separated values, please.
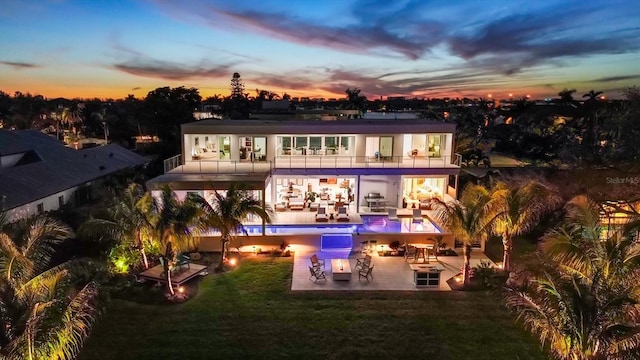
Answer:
[0, 0, 640, 99]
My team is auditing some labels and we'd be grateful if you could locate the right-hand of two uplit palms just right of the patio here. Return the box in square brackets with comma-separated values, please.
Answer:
[489, 180, 561, 271]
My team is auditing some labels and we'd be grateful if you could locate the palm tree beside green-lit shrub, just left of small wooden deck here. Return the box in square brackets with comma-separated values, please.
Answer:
[79, 183, 152, 269]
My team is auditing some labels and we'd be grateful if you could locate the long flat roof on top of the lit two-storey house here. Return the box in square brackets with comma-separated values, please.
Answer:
[182, 118, 456, 134]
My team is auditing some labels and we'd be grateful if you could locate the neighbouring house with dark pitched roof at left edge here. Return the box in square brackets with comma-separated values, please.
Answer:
[0, 130, 146, 221]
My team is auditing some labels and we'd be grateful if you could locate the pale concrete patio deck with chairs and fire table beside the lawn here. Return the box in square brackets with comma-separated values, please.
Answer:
[291, 250, 495, 291]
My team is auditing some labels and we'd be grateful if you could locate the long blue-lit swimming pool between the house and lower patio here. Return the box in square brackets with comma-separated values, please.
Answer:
[228, 215, 442, 235]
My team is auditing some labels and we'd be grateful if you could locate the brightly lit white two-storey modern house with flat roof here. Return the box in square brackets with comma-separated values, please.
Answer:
[148, 118, 460, 231]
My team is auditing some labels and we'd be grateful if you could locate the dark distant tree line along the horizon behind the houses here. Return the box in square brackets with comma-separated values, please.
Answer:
[0, 73, 640, 166]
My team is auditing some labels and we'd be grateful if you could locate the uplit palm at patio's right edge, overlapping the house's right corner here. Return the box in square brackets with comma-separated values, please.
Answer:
[434, 185, 493, 285]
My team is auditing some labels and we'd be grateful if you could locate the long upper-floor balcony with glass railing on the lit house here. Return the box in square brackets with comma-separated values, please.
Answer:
[164, 154, 460, 174]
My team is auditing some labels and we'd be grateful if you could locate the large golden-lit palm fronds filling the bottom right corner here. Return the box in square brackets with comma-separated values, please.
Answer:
[507, 264, 640, 360]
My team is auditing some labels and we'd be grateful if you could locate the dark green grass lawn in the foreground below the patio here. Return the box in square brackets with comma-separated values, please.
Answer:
[80, 258, 545, 360]
